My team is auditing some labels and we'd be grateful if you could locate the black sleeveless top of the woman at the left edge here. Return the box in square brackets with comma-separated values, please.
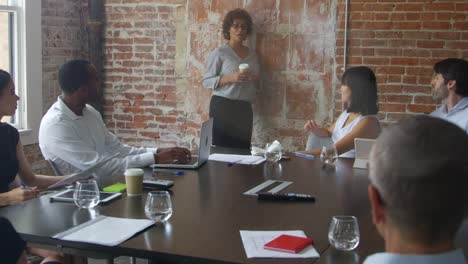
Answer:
[0, 122, 19, 193]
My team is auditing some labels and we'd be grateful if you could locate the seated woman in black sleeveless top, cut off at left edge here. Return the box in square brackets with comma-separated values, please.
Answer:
[0, 70, 63, 263]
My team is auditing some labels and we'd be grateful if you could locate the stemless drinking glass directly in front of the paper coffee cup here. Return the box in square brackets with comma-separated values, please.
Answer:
[145, 191, 172, 222]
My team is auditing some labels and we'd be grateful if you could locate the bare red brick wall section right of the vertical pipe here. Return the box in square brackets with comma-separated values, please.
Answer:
[336, 0, 468, 121]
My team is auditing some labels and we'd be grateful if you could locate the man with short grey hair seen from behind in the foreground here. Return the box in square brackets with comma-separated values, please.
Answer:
[364, 116, 468, 264]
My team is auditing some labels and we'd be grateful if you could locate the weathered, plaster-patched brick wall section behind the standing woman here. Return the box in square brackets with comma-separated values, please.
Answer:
[105, 0, 336, 149]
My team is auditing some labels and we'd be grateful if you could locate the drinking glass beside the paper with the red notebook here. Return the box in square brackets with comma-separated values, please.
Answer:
[328, 215, 360, 251]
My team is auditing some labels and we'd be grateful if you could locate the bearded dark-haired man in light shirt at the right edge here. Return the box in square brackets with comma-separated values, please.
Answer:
[431, 59, 468, 133]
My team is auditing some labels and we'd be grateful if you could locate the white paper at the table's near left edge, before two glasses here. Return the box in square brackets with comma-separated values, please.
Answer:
[53, 215, 155, 246]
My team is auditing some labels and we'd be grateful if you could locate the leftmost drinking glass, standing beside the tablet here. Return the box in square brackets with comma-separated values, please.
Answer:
[73, 180, 100, 208]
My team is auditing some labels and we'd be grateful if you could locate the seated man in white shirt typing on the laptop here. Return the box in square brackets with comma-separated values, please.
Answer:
[39, 60, 191, 182]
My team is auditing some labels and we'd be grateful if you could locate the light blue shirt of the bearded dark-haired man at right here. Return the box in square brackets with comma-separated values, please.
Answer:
[431, 97, 468, 133]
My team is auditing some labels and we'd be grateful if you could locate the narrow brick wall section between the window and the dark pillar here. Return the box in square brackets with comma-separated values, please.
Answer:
[24, 0, 87, 174]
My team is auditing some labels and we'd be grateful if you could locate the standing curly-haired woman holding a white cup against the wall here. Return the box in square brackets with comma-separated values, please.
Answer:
[203, 8, 260, 149]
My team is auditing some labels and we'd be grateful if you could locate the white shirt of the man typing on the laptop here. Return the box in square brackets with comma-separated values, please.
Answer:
[39, 97, 156, 184]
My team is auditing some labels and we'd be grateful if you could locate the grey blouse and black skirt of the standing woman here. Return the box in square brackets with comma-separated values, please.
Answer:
[203, 44, 260, 149]
